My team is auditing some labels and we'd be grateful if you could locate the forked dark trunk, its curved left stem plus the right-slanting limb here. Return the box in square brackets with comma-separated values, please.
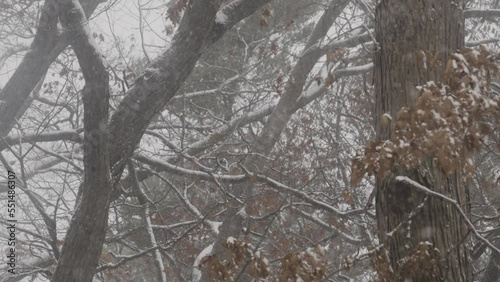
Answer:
[47, 0, 269, 282]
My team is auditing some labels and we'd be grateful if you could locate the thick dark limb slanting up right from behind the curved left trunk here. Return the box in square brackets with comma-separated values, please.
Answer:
[110, 0, 269, 187]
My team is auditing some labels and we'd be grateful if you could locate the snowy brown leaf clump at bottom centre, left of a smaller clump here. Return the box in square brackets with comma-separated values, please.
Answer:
[199, 238, 269, 281]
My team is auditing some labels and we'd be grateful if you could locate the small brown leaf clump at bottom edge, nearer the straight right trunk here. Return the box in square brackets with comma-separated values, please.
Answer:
[279, 246, 327, 282]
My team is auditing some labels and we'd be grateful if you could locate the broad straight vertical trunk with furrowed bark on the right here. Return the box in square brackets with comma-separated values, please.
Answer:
[374, 0, 472, 282]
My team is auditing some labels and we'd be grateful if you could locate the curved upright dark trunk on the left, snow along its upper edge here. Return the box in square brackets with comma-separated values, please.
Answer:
[50, 0, 112, 282]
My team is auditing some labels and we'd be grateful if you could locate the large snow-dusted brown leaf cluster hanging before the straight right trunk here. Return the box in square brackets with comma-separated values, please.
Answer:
[351, 46, 500, 185]
